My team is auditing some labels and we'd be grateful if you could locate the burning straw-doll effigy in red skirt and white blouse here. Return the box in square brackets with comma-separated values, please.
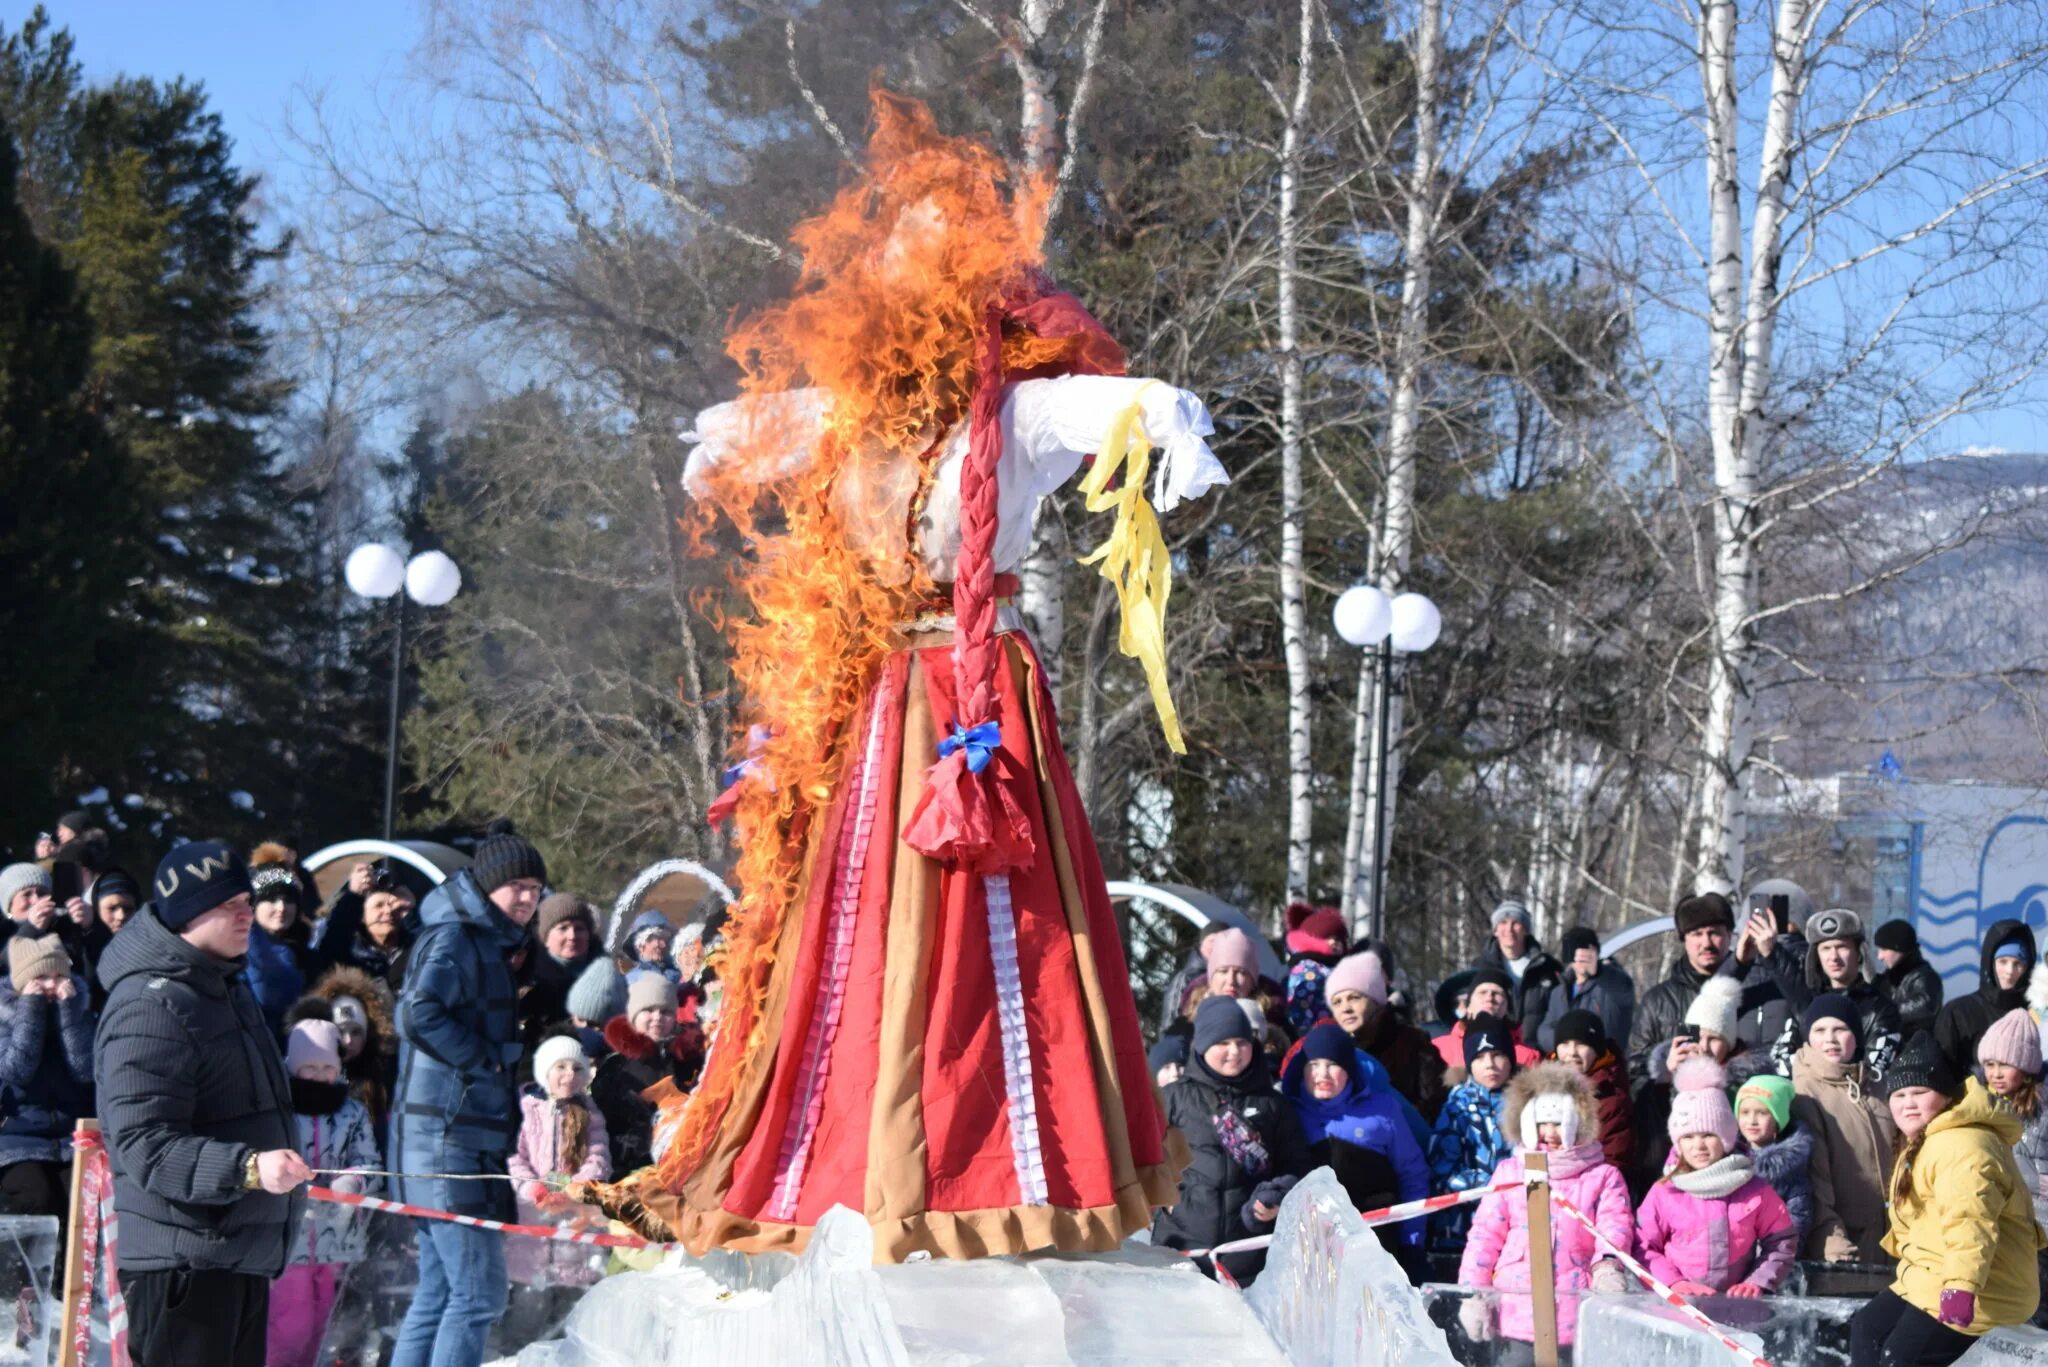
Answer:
[602, 94, 1227, 1260]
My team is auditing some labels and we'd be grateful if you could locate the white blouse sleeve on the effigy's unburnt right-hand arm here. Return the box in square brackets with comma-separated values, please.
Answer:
[1004, 375, 1231, 512]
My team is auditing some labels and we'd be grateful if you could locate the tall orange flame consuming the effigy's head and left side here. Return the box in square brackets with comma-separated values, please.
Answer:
[662, 90, 1067, 1189]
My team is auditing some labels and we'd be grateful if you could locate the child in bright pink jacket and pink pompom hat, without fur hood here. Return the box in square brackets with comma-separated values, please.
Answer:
[1636, 1058, 1798, 1295]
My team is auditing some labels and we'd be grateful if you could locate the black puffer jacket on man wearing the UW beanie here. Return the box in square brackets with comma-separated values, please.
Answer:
[94, 906, 305, 1277]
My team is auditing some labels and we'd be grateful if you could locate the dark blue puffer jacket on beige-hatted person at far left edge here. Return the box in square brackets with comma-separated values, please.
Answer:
[0, 978, 92, 1168]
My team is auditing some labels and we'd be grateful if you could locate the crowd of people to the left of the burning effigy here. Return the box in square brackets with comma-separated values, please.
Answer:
[0, 814, 719, 1367]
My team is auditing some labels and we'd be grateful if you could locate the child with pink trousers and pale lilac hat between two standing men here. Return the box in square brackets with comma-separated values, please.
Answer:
[264, 1019, 383, 1367]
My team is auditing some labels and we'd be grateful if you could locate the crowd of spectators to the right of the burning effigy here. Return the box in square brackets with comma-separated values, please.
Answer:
[1151, 879, 2048, 1367]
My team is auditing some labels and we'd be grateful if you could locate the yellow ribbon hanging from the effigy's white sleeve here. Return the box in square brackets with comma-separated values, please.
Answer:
[1081, 389, 1188, 754]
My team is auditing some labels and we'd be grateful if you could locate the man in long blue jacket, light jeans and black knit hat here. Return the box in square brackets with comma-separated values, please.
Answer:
[391, 832, 547, 1367]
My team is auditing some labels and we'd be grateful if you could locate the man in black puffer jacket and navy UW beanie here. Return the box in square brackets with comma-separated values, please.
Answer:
[94, 840, 311, 1367]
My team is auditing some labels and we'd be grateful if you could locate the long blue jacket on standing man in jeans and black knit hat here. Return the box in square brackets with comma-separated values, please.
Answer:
[391, 869, 530, 1219]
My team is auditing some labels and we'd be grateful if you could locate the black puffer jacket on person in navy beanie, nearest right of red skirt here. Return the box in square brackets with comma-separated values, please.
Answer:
[1153, 1058, 1311, 1248]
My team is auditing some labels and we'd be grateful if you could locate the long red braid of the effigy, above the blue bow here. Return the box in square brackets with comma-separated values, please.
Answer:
[952, 299, 1004, 726]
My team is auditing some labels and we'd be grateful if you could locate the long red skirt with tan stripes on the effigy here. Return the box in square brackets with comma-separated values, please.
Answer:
[649, 633, 1186, 1260]
